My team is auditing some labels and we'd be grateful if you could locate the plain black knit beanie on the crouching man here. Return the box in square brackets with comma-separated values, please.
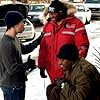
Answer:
[57, 44, 79, 61]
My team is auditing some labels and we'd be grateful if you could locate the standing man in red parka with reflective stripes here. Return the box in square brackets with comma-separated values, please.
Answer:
[38, 0, 89, 83]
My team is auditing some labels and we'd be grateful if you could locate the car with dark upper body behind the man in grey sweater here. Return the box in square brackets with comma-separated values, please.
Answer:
[0, 4, 35, 41]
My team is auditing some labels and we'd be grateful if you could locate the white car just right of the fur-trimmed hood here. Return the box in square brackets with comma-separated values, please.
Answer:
[74, 3, 91, 24]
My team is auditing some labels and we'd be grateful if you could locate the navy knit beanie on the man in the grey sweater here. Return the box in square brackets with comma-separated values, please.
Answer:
[4, 11, 24, 28]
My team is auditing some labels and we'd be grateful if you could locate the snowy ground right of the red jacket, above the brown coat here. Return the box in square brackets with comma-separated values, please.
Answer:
[85, 22, 100, 72]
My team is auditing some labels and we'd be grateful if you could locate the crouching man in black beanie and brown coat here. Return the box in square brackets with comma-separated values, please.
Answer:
[46, 44, 100, 100]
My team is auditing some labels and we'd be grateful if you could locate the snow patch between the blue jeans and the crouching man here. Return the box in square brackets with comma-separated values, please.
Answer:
[25, 69, 50, 100]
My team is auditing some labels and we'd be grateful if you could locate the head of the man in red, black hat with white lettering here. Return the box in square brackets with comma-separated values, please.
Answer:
[48, 0, 67, 22]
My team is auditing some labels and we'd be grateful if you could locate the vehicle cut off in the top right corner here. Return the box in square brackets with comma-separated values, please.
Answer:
[85, 0, 100, 18]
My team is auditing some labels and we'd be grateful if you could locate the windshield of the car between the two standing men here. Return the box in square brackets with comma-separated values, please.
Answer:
[29, 5, 45, 12]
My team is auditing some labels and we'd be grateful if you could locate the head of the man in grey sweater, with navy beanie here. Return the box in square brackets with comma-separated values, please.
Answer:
[4, 11, 25, 33]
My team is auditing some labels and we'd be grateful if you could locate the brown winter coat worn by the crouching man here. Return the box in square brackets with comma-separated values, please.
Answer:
[60, 58, 100, 100]
